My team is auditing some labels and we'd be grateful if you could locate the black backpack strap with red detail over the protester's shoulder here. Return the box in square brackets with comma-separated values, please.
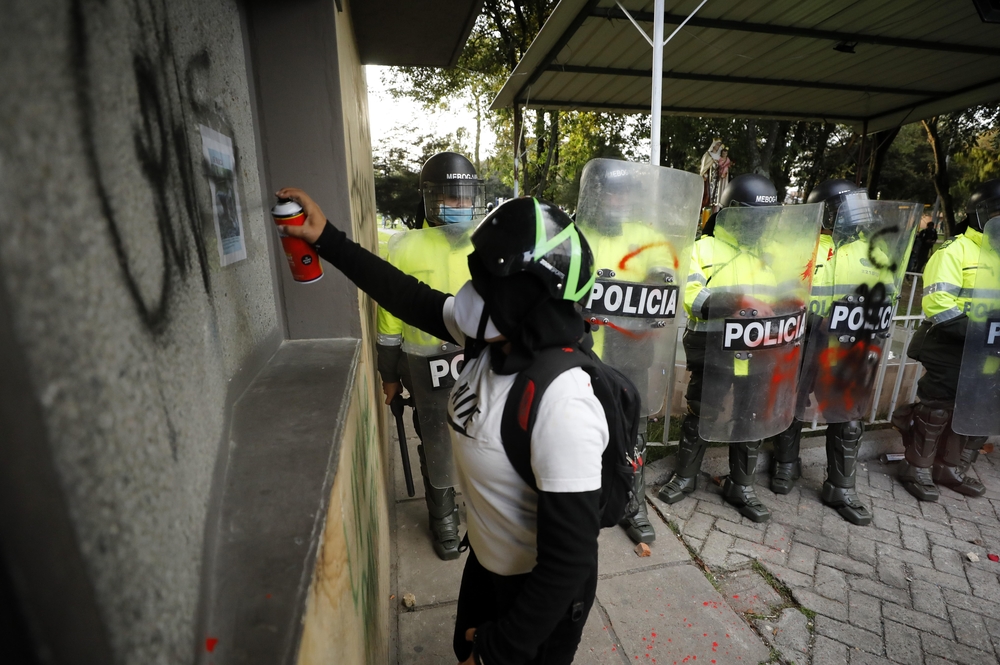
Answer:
[500, 346, 593, 492]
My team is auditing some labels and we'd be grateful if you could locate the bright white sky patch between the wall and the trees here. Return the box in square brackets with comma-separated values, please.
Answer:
[365, 65, 496, 158]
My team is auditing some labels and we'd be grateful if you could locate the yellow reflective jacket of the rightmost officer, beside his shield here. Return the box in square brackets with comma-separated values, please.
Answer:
[920, 227, 983, 325]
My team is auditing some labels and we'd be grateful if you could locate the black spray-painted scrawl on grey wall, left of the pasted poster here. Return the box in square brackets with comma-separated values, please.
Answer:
[70, 0, 238, 335]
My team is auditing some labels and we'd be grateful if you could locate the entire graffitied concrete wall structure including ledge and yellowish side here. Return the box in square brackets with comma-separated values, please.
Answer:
[0, 0, 398, 663]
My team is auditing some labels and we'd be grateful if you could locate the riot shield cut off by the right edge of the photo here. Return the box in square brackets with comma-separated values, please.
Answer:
[951, 217, 1000, 436]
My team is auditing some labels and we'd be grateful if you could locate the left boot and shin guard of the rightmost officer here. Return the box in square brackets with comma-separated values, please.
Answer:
[892, 402, 951, 501]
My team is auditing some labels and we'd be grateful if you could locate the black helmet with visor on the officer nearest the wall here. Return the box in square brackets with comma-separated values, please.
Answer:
[420, 152, 486, 226]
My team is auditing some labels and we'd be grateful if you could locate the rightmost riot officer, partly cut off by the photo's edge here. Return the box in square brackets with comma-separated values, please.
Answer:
[892, 179, 1000, 501]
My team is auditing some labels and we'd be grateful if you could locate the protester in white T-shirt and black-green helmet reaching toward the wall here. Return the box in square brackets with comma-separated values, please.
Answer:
[278, 188, 608, 665]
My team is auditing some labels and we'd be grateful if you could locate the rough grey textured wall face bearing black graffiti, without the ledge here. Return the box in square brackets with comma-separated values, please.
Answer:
[0, 0, 281, 663]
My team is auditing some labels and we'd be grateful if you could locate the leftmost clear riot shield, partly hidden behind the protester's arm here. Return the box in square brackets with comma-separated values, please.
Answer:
[389, 223, 475, 489]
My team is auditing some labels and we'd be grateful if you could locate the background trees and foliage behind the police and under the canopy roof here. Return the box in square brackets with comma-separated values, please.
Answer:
[380, 0, 1000, 217]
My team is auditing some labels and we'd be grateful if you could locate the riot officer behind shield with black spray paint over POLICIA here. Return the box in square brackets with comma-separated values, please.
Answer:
[771, 179, 918, 526]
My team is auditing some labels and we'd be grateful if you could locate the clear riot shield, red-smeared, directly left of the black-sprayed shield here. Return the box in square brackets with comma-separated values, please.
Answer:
[699, 203, 823, 443]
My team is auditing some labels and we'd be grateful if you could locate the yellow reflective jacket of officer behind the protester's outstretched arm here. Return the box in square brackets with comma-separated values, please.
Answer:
[378, 222, 472, 351]
